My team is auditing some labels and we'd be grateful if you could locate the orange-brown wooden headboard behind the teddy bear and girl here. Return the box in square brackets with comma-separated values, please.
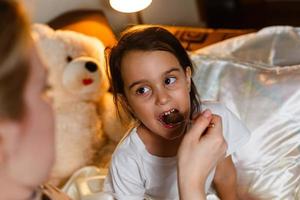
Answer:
[48, 10, 254, 51]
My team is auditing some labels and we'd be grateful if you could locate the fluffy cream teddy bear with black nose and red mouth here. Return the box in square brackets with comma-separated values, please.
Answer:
[33, 24, 125, 184]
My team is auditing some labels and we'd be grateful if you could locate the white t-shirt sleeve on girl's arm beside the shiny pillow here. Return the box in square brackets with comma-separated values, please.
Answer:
[220, 104, 250, 156]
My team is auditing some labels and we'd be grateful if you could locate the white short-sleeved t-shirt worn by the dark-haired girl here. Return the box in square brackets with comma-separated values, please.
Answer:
[104, 102, 249, 200]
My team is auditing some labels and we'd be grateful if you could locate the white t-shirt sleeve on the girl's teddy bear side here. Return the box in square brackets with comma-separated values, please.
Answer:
[104, 152, 145, 200]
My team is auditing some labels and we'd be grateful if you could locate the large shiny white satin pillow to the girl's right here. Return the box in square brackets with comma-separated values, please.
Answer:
[191, 26, 300, 200]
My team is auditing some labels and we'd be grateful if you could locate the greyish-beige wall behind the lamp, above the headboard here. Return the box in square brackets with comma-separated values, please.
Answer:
[23, 0, 204, 33]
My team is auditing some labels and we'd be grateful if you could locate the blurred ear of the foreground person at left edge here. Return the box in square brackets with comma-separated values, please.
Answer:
[0, 119, 21, 165]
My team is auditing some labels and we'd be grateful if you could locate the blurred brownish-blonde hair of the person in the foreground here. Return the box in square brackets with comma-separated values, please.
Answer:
[0, 0, 30, 120]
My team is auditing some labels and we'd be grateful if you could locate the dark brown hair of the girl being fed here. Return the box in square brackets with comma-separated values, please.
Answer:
[108, 26, 200, 122]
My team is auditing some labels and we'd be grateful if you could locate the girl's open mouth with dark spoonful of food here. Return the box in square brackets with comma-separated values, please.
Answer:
[159, 108, 184, 127]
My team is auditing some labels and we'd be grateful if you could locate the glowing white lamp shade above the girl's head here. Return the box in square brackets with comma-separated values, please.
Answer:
[109, 0, 152, 13]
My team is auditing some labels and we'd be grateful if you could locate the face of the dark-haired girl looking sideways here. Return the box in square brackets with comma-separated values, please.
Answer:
[121, 50, 191, 140]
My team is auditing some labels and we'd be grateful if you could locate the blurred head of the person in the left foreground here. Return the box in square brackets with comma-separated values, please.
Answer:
[0, 0, 54, 199]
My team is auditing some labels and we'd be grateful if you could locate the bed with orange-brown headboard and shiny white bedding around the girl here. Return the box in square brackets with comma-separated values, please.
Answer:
[45, 10, 300, 200]
